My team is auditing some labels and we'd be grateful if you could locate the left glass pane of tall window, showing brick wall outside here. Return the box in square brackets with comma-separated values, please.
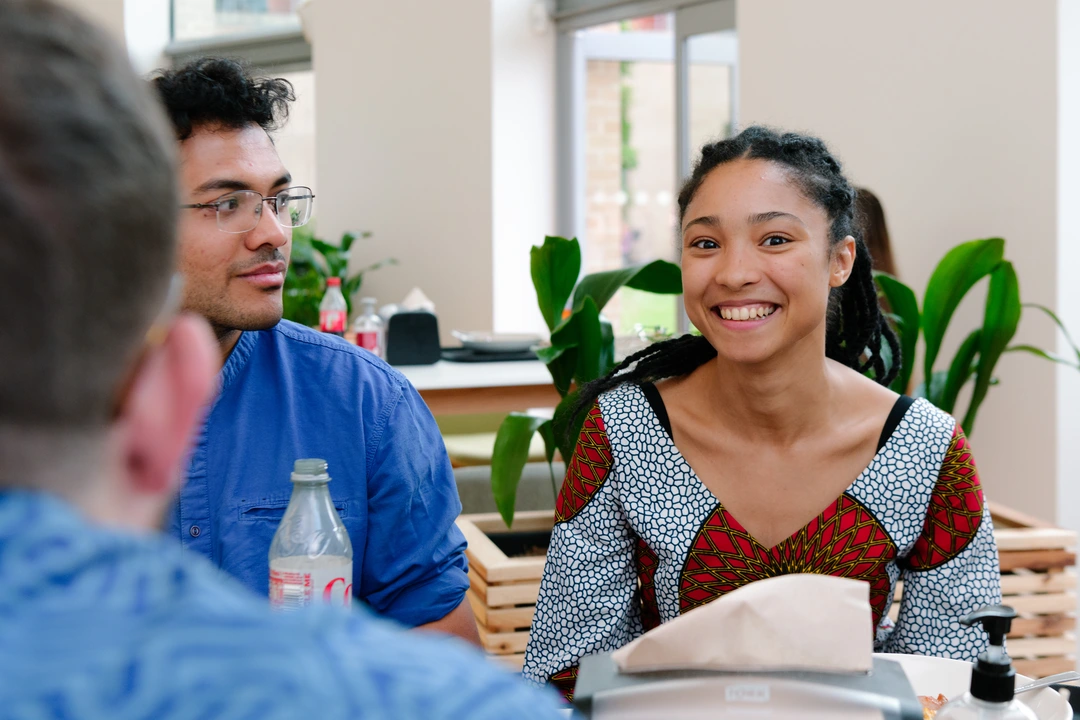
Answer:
[583, 15, 676, 336]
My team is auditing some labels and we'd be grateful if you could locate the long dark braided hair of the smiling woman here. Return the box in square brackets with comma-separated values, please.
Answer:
[573, 125, 900, 417]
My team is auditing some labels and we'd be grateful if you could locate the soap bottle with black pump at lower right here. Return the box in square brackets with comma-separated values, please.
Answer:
[934, 604, 1037, 720]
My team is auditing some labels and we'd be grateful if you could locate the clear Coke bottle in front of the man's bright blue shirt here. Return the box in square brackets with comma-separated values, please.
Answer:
[270, 459, 352, 610]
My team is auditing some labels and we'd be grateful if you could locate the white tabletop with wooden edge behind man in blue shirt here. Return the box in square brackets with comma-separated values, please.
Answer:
[395, 361, 562, 416]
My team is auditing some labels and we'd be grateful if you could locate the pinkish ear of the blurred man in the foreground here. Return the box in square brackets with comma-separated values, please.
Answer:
[117, 315, 220, 499]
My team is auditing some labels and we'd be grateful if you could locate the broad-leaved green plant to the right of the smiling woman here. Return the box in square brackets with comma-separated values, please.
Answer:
[876, 237, 1080, 436]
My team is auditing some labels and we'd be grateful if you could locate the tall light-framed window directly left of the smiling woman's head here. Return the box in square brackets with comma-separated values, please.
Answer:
[559, 1, 738, 336]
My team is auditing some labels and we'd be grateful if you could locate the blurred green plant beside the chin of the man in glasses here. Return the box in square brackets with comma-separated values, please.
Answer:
[282, 226, 397, 327]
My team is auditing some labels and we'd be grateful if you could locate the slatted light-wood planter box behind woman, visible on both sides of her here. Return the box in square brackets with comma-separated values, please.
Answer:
[458, 503, 1077, 678]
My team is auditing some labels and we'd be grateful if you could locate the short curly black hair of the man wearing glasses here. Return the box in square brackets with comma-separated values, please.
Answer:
[151, 57, 296, 141]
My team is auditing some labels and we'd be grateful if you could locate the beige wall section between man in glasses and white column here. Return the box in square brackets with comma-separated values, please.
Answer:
[312, 0, 492, 340]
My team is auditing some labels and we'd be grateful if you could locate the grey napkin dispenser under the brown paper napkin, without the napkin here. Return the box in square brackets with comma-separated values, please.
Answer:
[573, 653, 922, 720]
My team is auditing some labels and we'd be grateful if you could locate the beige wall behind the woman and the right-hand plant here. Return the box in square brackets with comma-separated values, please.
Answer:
[738, 0, 1058, 519]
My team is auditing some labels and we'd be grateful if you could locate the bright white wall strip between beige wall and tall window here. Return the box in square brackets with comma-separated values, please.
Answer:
[491, 0, 555, 332]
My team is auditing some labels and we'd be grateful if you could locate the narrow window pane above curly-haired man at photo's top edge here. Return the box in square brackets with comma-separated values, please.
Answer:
[173, 0, 302, 40]
